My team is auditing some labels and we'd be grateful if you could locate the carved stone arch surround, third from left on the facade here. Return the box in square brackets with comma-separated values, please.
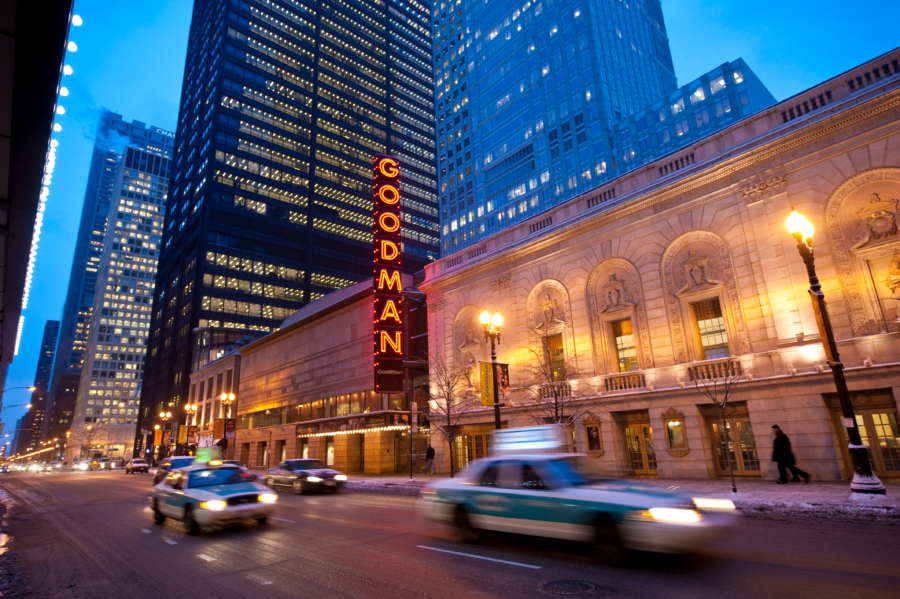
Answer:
[585, 258, 656, 374]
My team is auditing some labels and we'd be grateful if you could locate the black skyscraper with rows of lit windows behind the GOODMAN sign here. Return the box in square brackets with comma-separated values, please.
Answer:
[141, 0, 438, 436]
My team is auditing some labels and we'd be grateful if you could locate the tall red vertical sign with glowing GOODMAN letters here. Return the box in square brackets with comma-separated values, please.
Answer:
[374, 154, 404, 393]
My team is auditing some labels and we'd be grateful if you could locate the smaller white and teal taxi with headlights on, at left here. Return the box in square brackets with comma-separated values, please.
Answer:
[150, 464, 278, 535]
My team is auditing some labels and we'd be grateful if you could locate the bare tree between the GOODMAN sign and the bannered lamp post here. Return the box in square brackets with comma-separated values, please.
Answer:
[428, 354, 475, 478]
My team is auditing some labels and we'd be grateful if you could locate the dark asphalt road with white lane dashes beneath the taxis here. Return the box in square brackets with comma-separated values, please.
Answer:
[0, 472, 900, 599]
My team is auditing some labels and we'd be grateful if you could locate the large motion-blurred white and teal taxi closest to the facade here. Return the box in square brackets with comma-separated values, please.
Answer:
[418, 454, 736, 560]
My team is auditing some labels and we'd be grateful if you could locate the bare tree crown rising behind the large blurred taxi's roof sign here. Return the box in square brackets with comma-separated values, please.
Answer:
[519, 340, 597, 434]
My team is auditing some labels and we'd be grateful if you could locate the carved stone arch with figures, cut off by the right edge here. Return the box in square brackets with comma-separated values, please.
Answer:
[825, 167, 900, 337]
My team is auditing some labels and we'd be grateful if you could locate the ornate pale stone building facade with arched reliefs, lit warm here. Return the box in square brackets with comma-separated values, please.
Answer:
[420, 50, 900, 479]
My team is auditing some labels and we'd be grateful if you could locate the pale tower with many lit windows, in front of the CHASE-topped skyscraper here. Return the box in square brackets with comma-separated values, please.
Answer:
[68, 146, 170, 457]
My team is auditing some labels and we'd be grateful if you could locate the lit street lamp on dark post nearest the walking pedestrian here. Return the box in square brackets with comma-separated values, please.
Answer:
[785, 210, 885, 495]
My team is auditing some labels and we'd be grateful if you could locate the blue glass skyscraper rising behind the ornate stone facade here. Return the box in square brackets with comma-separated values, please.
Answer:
[434, 0, 774, 254]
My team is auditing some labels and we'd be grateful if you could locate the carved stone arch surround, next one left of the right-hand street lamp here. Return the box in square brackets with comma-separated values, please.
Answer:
[660, 231, 752, 364]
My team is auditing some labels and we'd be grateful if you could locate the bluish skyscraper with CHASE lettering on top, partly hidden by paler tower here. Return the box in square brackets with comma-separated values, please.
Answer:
[50, 110, 175, 438]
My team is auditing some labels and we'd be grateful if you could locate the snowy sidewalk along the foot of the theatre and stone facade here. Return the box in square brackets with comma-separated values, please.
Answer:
[347, 472, 900, 524]
